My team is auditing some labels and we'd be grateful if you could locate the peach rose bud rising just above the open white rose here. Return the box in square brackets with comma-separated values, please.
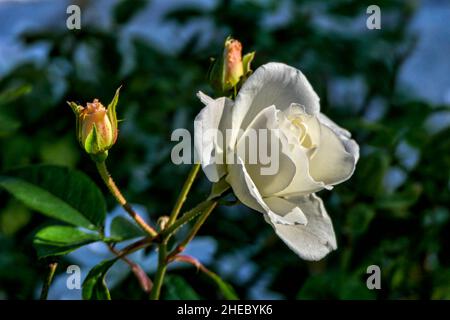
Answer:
[209, 37, 255, 94]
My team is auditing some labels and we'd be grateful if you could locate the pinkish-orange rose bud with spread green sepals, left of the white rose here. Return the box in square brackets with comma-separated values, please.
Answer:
[67, 88, 120, 161]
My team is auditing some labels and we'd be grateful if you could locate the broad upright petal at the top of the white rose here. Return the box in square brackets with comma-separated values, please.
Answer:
[232, 62, 320, 149]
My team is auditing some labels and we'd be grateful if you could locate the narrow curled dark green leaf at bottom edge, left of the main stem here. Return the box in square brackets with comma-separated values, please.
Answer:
[82, 258, 118, 300]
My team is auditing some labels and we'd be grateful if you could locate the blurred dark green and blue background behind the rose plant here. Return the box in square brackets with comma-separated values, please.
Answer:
[0, 0, 450, 299]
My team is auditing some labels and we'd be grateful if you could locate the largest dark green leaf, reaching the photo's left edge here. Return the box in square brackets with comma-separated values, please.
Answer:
[0, 165, 106, 229]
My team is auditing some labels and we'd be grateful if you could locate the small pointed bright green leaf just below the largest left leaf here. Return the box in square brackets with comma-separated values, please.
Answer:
[33, 226, 101, 258]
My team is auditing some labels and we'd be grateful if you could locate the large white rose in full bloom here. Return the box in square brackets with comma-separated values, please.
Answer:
[195, 63, 359, 260]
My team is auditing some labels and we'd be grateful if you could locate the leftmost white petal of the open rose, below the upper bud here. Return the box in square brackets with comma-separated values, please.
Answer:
[194, 93, 233, 182]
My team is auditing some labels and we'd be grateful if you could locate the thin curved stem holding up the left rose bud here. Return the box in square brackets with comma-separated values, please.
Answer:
[95, 161, 158, 237]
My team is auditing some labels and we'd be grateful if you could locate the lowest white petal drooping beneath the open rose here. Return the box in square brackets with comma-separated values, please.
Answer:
[265, 194, 337, 260]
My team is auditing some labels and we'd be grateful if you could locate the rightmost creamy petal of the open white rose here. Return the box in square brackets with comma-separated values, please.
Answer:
[310, 115, 359, 185]
